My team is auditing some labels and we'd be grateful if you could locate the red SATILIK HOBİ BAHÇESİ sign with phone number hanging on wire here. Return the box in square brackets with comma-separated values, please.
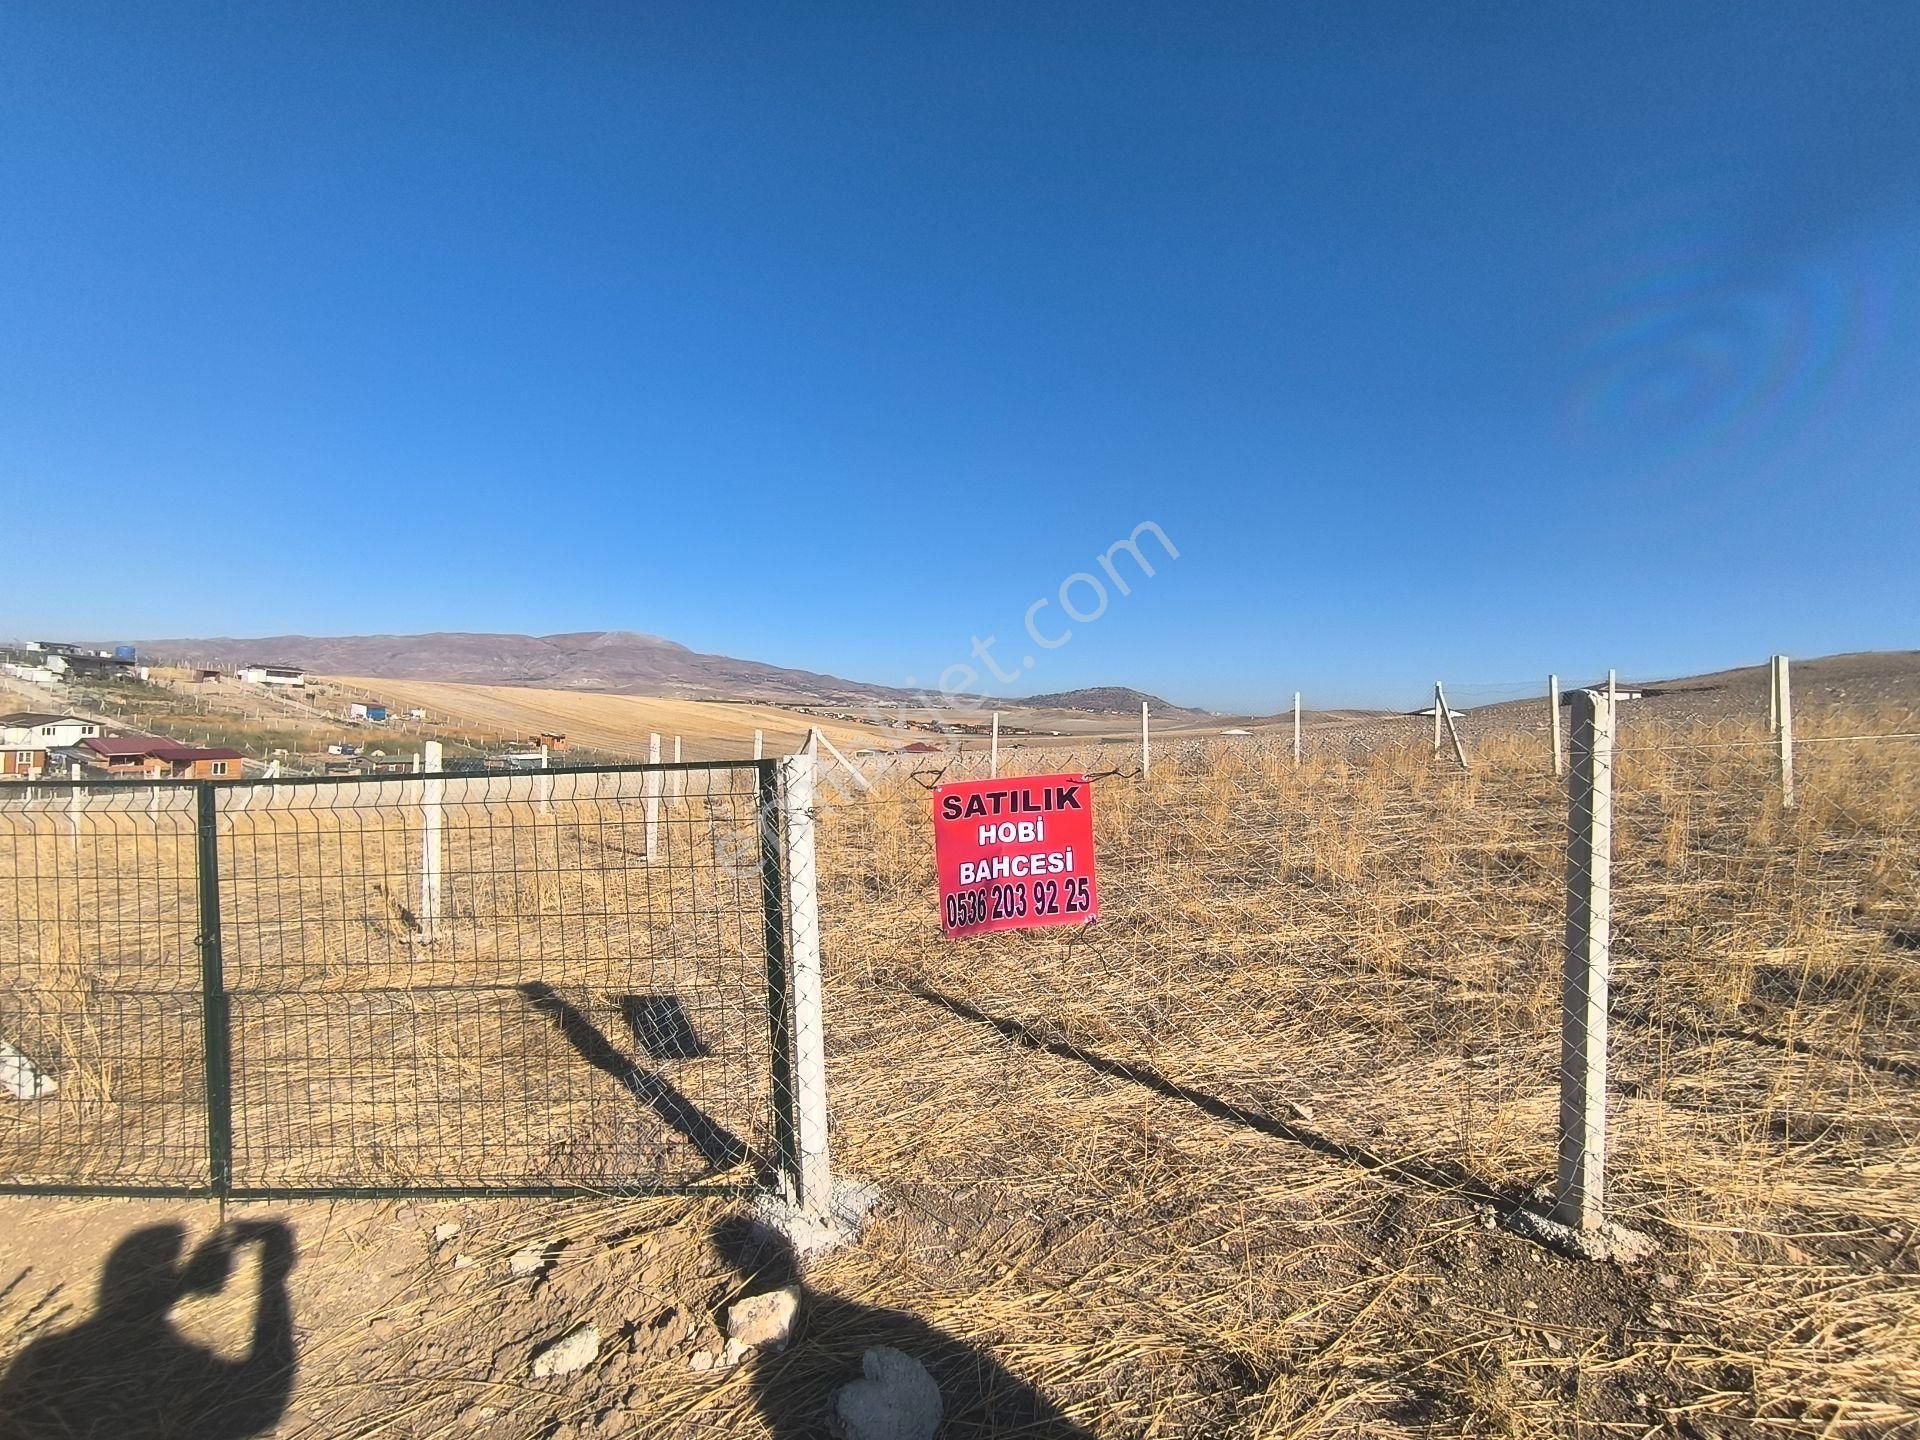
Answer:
[933, 776, 1100, 935]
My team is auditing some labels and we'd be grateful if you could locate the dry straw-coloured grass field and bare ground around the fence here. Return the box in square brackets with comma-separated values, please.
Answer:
[0, 702, 1920, 1440]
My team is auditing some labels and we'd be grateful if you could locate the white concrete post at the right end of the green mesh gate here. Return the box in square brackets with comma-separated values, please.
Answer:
[780, 755, 833, 1213]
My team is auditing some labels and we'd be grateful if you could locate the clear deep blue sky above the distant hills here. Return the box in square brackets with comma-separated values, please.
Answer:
[0, 0, 1920, 708]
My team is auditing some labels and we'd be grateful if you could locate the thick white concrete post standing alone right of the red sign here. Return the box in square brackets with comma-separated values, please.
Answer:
[1553, 689, 1613, 1231]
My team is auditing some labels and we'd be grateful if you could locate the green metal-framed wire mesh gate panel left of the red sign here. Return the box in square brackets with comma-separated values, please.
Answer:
[0, 762, 810, 1196]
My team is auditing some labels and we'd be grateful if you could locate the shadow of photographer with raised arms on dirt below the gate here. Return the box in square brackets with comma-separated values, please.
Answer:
[0, 1221, 298, 1440]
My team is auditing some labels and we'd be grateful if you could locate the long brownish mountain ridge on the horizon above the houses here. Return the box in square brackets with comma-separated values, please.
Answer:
[140, 630, 908, 703]
